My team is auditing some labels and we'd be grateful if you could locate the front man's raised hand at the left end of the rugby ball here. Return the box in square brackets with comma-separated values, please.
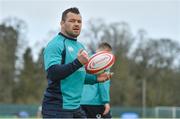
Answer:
[77, 49, 89, 65]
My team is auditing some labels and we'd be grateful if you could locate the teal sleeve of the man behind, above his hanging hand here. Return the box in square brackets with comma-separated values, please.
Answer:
[98, 80, 110, 104]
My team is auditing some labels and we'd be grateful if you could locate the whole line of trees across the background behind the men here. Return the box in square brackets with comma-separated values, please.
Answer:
[0, 20, 180, 107]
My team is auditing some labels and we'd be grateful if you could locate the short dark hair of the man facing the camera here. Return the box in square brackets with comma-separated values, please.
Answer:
[61, 7, 80, 21]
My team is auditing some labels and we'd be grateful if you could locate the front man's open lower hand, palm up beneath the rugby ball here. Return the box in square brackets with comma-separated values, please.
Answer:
[97, 72, 114, 82]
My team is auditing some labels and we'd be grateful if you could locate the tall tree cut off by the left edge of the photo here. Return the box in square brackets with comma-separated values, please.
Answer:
[0, 24, 19, 103]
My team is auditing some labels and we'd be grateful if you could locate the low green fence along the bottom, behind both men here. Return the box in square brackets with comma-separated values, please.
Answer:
[0, 104, 180, 118]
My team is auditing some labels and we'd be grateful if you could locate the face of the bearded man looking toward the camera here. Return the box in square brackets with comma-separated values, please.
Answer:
[61, 12, 82, 38]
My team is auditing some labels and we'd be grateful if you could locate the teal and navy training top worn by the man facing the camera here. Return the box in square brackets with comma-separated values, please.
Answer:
[43, 33, 97, 110]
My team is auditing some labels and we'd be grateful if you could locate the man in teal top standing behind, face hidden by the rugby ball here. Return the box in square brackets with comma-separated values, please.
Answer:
[81, 42, 112, 118]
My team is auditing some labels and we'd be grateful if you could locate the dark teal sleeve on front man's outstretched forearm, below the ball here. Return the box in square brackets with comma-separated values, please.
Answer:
[84, 73, 98, 85]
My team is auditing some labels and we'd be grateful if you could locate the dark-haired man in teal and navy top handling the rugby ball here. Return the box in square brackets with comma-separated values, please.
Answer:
[42, 8, 111, 118]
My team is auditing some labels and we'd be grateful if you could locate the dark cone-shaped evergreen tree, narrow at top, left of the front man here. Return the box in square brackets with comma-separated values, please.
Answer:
[13, 48, 37, 103]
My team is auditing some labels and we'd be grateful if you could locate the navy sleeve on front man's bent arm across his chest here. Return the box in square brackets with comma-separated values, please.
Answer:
[47, 59, 83, 80]
